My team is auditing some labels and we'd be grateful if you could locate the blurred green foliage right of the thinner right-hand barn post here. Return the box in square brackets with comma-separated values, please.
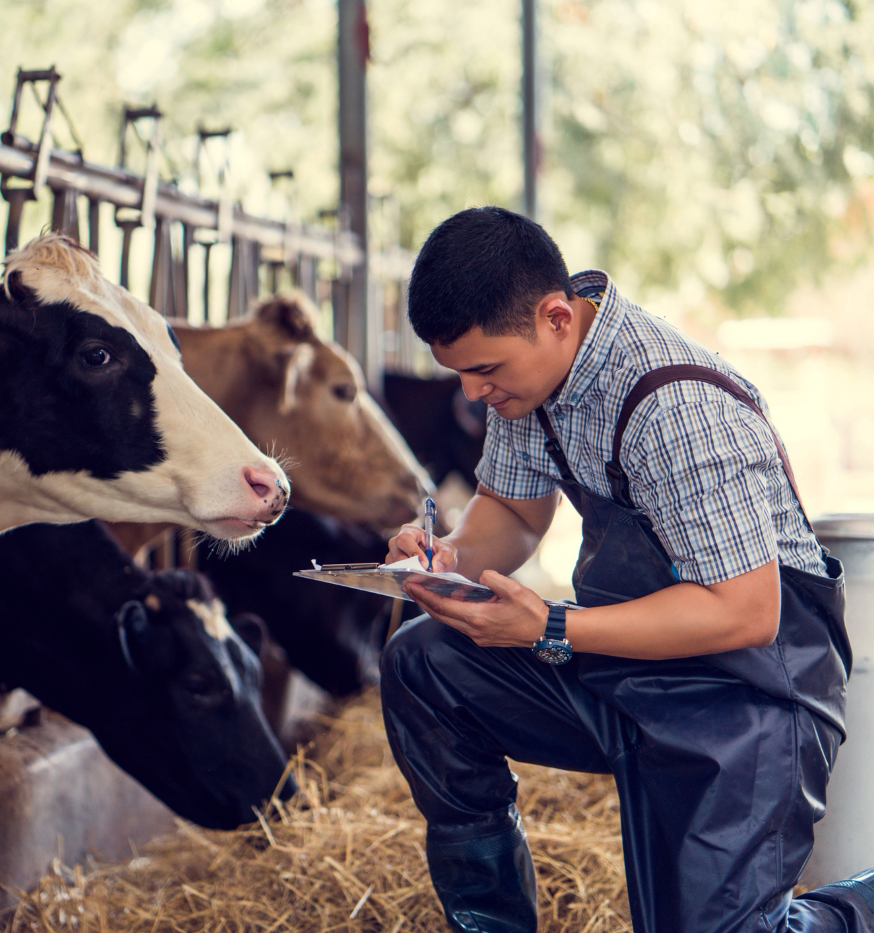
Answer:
[547, 0, 874, 312]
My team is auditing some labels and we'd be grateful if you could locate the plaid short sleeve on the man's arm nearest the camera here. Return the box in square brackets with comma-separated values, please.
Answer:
[623, 399, 783, 585]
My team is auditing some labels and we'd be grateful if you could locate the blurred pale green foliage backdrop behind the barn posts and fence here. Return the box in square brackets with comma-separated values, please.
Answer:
[0, 0, 874, 313]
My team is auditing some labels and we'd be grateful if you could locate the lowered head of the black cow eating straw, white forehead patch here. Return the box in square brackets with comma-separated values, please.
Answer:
[111, 571, 296, 829]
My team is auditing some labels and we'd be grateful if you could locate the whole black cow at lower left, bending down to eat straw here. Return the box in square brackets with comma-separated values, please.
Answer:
[0, 522, 296, 829]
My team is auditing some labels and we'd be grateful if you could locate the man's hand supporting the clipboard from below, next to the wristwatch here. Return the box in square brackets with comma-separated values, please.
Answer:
[404, 570, 548, 648]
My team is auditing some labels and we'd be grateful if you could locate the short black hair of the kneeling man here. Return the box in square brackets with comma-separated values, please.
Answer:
[407, 207, 571, 346]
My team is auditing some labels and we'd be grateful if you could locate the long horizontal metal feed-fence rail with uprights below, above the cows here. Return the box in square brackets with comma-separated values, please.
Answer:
[0, 134, 421, 375]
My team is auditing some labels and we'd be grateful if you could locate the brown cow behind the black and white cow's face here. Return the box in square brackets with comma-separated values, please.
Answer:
[113, 295, 431, 553]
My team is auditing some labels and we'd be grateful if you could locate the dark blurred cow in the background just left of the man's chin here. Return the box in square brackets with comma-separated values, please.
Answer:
[382, 373, 486, 489]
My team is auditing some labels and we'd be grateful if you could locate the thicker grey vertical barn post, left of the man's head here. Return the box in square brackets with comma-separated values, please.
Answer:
[335, 0, 368, 383]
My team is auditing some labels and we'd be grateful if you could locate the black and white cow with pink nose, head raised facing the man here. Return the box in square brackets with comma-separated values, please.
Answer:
[0, 234, 294, 541]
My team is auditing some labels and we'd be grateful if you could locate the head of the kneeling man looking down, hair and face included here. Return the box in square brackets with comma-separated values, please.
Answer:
[409, 207, 593, 420]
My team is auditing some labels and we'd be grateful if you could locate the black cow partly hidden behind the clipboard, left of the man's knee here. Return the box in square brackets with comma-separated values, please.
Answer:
[200, 509, 396, 696]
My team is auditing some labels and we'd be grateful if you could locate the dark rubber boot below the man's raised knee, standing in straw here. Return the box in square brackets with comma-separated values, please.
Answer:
[425, 805, 537, 933]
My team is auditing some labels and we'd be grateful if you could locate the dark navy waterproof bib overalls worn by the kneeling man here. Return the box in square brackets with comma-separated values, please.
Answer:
[382, 367, 874, 933]
